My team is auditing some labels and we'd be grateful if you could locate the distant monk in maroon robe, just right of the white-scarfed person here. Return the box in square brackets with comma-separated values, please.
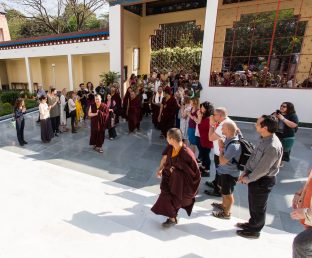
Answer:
[158, 86, 178, 137]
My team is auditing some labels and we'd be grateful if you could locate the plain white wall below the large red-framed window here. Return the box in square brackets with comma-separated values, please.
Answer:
[201, 87, 312, 123]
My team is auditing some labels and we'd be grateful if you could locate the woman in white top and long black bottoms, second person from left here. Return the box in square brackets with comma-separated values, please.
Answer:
[39, 96, 54, 143]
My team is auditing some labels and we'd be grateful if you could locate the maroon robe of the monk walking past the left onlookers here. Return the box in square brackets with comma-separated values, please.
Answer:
[90, 103, 109, 148]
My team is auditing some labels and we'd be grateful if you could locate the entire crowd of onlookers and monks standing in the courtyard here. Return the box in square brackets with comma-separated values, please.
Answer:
[14, 71, 312, 257]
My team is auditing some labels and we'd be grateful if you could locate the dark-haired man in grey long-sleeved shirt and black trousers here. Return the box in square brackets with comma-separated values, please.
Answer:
[236, 115, 283, 239]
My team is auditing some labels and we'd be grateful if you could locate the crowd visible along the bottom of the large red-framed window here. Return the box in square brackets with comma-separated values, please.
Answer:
[210, 67, 312, 88]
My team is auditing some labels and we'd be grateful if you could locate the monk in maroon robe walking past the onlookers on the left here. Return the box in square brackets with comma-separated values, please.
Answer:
[88, 95, 109, 153]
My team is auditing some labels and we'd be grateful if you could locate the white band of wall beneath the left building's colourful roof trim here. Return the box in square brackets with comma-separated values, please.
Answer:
[0, 40, 110, 60]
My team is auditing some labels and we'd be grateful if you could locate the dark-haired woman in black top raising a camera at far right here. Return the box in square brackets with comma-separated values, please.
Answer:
[273, 102, 299, 162]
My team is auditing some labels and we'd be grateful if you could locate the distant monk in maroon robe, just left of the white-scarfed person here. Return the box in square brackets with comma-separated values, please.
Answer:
[126, 91, 141, 133]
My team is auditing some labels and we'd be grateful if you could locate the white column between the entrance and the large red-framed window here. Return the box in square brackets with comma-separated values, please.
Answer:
[200, 0, 218, 100]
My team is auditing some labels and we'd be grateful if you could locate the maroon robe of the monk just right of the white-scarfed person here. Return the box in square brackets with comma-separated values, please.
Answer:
[160, 96, 178, 137]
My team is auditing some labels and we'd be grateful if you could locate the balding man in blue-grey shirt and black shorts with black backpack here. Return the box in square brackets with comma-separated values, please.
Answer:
[212, 121, 242, 219]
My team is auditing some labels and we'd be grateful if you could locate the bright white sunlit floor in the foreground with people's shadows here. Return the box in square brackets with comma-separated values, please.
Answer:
[0, 148, 294, 258]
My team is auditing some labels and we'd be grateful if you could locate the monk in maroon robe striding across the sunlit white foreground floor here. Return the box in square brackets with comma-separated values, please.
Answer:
[152, 128, 200, 227]
